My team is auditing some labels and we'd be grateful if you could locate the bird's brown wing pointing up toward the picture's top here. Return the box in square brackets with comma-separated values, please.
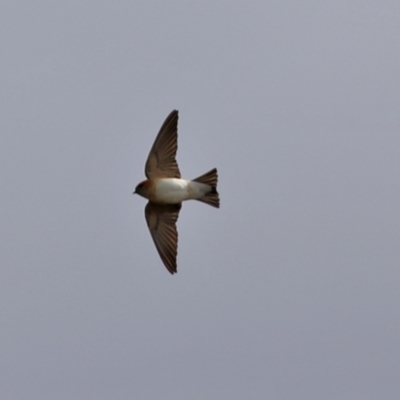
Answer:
[144, 110, 181, 179]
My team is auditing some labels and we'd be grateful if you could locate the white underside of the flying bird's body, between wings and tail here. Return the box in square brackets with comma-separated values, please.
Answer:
[156, 178, 211, 204]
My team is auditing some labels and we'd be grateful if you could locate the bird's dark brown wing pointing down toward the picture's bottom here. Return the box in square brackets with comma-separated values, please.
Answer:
[145, 201, 181, 274]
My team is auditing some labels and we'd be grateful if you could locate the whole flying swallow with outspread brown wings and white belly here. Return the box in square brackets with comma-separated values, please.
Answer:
[133, 110, 220, 274]
